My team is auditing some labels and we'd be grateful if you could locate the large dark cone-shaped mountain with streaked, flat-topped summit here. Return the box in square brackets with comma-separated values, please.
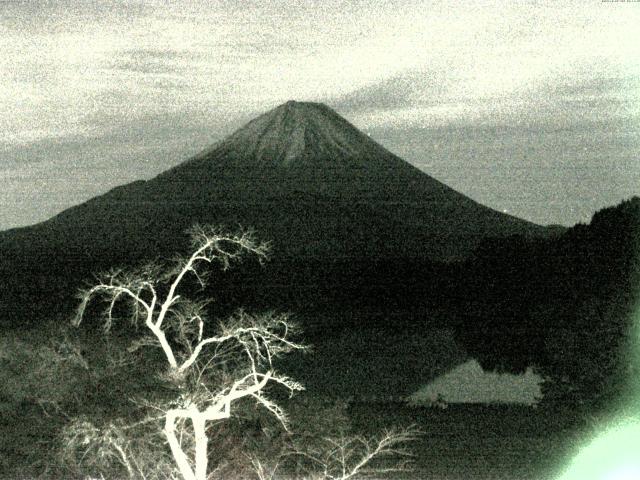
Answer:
[0, 102, 547, 324]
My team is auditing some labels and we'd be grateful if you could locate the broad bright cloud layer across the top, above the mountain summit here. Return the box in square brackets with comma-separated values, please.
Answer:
[0, 0, 633, 141]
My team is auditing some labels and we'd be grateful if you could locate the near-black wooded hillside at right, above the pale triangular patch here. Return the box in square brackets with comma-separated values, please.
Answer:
[456, 197, 640, 410]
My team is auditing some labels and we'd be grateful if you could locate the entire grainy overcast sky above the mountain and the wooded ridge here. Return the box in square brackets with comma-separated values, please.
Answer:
[0, 0, 640, 229]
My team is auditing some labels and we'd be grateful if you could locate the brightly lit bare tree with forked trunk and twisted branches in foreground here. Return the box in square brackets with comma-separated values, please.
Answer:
[67, 226, 303, 480]
